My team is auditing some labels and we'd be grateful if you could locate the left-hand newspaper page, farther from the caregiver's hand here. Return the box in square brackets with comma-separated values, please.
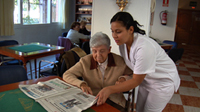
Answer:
[19, 78, 78, 100]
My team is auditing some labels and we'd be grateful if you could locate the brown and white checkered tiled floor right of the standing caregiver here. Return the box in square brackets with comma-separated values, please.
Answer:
[163, 45, 200, 112]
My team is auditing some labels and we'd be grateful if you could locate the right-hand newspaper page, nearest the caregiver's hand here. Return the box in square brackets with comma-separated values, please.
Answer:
[38, 90, 96, 112]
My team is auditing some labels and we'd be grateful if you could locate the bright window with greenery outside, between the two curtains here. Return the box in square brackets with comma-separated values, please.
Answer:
[14, 0, 59, 25]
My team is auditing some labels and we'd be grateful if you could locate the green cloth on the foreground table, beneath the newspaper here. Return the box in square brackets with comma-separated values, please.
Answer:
[0, 89, 95, 112]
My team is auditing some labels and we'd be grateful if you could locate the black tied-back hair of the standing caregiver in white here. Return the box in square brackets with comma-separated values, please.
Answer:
[110, 12, 145, 35]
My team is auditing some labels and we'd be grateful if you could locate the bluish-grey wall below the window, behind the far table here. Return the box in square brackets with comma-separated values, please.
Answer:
[0, 0, 75, 45]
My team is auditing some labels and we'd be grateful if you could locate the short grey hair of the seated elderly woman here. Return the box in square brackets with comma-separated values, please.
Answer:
[90, 32, 110, 49]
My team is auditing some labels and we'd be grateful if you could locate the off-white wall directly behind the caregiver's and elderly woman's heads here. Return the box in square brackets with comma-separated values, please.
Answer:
[92, 0, 151, 54]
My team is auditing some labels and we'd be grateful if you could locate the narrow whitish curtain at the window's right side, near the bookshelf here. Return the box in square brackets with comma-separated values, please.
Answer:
[59, 0, 69, 29]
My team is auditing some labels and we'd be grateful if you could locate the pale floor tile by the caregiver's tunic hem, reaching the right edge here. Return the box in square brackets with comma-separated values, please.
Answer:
[179, 86, 200, 97]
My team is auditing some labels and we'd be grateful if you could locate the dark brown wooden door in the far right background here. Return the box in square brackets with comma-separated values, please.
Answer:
[175, 9, 200, 45]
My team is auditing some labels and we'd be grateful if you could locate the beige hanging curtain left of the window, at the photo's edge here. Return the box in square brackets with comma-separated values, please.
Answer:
[0, 0, 15, 36]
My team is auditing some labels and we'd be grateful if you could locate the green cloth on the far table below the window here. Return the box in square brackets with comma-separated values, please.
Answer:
[9, 44, 51, 53]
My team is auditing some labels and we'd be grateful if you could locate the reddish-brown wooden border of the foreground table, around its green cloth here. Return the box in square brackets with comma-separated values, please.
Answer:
[0, 76, 120, 112]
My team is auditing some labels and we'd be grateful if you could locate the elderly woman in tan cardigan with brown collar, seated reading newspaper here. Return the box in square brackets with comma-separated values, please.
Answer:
[63, 32, 133, 107]
